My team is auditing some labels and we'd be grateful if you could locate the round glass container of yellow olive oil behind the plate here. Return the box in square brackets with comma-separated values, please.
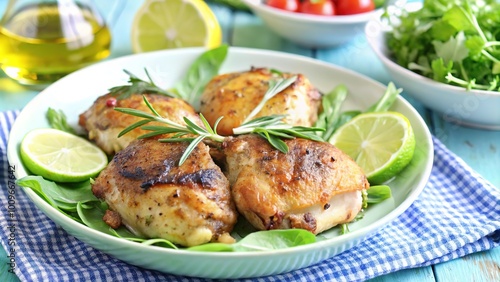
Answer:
[0, 0, 111, 85]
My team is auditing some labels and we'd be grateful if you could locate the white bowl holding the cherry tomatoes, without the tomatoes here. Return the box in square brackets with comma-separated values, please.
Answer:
[243, 0, 380, 48]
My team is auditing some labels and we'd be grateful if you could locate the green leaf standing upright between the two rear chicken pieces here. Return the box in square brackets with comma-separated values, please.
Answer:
[172, 45, 228, 109]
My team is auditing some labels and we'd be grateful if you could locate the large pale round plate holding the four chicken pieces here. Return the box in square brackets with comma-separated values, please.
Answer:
[8, 47, 433, 278]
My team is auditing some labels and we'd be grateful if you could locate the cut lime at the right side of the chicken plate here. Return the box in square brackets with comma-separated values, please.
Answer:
[330, 112, 415, 184]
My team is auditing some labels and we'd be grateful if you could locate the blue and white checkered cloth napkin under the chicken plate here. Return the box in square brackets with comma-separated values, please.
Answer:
[0, 112, 500, 281]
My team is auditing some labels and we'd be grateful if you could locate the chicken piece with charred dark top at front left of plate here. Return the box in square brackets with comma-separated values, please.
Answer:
[92, 139, 237, 247]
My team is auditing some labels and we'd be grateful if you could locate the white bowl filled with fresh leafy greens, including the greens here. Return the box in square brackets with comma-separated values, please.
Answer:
[365, 0, 500, 130]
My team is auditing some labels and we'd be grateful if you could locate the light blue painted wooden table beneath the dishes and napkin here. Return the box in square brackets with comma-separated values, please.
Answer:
[0, 1, 500, 282]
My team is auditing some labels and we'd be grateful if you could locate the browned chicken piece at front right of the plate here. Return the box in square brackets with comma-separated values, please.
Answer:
[223, 135, 369, 234]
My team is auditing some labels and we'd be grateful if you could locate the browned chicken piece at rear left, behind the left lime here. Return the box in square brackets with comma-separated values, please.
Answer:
[79, 94, 201, 155]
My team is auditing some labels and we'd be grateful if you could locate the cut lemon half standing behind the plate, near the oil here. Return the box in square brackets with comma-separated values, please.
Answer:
[131, 0, 222, 53]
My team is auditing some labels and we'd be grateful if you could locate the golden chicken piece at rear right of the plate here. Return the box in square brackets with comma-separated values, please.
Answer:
[200, 68, 321, 136]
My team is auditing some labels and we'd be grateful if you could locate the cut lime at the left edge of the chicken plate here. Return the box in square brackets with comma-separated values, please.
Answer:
[20, 128, 108, 182]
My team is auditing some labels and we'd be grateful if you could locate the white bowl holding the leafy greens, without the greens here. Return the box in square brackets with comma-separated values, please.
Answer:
[365, 8, 500, 130]
